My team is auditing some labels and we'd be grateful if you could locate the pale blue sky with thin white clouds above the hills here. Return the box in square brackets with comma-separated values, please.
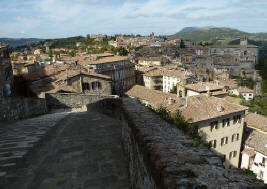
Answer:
[0, 0, 267, 39]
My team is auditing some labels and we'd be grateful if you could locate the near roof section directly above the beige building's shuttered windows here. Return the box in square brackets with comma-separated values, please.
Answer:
[180, 95, 248, 123]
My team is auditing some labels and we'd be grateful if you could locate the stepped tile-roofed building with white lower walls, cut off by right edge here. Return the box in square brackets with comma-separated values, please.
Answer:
[241, 113, 267, 184]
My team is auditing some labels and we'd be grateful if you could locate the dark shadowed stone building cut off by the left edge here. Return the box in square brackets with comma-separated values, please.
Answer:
[0, 43, 13, 97]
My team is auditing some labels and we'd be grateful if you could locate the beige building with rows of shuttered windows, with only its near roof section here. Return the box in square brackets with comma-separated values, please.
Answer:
[180, 95, 247, 168]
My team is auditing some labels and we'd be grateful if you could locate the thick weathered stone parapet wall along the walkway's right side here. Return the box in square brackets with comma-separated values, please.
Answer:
[86, 98, 263, 189]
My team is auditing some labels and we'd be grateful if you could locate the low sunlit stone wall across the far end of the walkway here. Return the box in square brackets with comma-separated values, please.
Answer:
[45, 93, 117, 109]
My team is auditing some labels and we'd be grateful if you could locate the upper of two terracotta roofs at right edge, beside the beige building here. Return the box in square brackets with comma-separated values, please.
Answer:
[245, 113, 267, 132]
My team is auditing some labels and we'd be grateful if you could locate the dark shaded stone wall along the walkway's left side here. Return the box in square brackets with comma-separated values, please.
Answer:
[0, 97, 47, 121]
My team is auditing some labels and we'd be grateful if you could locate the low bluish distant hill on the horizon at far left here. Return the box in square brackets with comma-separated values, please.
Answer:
[0, 38, 45, 47]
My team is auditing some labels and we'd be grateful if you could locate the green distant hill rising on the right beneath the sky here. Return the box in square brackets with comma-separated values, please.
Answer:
[169, 26, 267, 44]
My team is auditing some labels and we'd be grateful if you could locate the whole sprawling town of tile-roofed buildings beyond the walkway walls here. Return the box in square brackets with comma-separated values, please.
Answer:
[0, 33, 267, 183]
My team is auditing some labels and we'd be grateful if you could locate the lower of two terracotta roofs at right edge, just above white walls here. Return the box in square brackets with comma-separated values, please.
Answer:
[245, 130, 267, 155]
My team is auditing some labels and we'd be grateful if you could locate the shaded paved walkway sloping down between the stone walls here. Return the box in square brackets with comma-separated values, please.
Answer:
[0, 112, 128, 189]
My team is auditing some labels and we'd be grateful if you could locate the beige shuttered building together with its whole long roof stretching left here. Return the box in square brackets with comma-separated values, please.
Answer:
[126, 86, 247, 168]
